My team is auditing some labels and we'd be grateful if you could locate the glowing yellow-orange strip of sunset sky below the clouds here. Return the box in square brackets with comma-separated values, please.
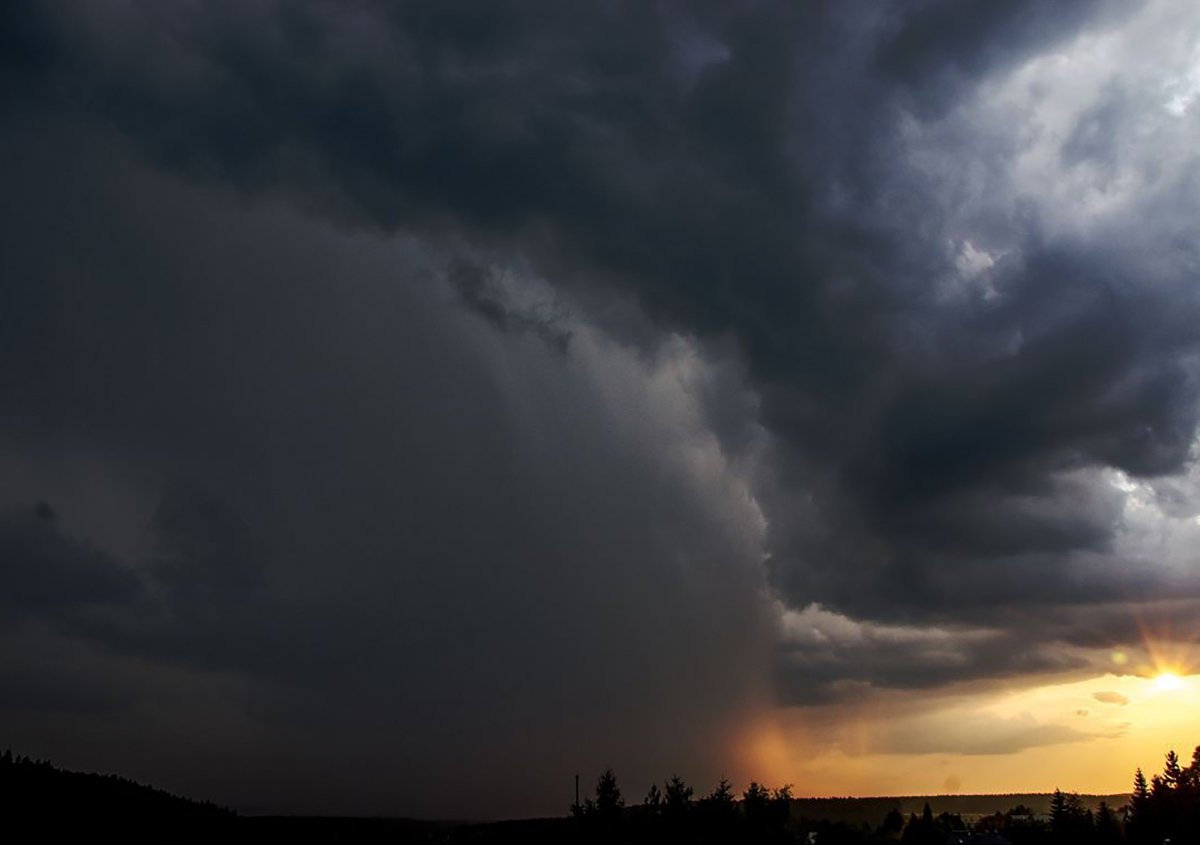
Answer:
[746, 673, 1200, 796]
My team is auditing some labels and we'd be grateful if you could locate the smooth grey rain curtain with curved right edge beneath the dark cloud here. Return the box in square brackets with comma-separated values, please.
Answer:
[0, 121, 769, 814]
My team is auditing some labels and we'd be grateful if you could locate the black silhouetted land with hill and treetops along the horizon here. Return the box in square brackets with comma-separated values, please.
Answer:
[0, 747, 1200, 845]
